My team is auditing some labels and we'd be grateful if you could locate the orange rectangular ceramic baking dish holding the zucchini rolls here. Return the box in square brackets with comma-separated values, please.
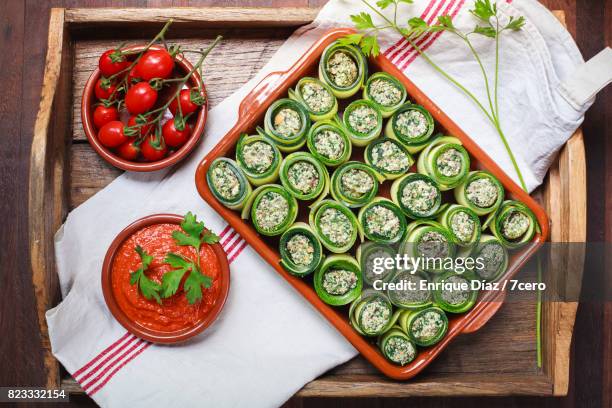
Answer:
[195, 29, 549, 380]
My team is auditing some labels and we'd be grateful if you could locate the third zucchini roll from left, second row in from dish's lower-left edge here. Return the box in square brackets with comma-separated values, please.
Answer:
[308, 200, 359, 254]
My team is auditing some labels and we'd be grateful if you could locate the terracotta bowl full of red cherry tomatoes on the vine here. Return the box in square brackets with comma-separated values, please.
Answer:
[81, 44, 208, 171]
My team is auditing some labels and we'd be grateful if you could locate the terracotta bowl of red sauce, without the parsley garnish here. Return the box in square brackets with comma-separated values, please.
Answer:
[102, 214, 230, 344]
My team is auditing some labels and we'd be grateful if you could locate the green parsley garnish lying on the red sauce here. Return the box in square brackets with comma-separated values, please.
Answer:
[130, 212, 219, 304]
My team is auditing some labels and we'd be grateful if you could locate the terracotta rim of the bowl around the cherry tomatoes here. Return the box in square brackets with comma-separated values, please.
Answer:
[81, 45, 208, 171]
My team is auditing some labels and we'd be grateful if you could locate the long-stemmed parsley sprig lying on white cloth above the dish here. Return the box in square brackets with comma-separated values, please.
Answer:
[340, 0, 527, 190]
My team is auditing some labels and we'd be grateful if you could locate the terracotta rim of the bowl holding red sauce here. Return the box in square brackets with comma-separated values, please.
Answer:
[102, 214, 230, 344]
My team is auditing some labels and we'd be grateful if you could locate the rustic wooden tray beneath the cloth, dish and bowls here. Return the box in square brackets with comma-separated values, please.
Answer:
[29, 8, 586, 397]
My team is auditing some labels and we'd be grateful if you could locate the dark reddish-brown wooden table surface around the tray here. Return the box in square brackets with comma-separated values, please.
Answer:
[0, 0, 612, 408]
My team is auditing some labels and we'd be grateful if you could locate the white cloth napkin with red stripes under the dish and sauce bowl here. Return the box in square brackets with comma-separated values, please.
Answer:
[47, 0, 588, 407]
